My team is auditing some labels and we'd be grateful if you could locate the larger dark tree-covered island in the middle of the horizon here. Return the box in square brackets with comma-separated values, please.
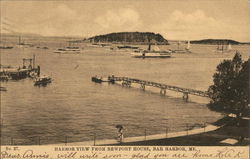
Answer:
[88, 32, 168, 45]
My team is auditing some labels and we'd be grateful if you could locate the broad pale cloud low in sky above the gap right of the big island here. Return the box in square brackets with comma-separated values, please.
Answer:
[152, 10, 244, 39]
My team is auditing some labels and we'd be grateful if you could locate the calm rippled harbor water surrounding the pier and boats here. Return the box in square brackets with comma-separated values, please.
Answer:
[1, 38, 250, 144]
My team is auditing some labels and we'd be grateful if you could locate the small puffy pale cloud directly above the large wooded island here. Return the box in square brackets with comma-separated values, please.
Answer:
[94, 8, 141, 32]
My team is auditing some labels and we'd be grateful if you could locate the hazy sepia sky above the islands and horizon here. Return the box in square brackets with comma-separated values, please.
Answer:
[0, 0, 250, 42]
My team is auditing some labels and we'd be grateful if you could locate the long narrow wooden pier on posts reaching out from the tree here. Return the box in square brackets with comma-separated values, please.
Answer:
[104, 76, 209, 101]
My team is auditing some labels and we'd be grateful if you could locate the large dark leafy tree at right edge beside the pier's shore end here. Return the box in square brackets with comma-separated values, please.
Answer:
[208, 52, 249, 117]
